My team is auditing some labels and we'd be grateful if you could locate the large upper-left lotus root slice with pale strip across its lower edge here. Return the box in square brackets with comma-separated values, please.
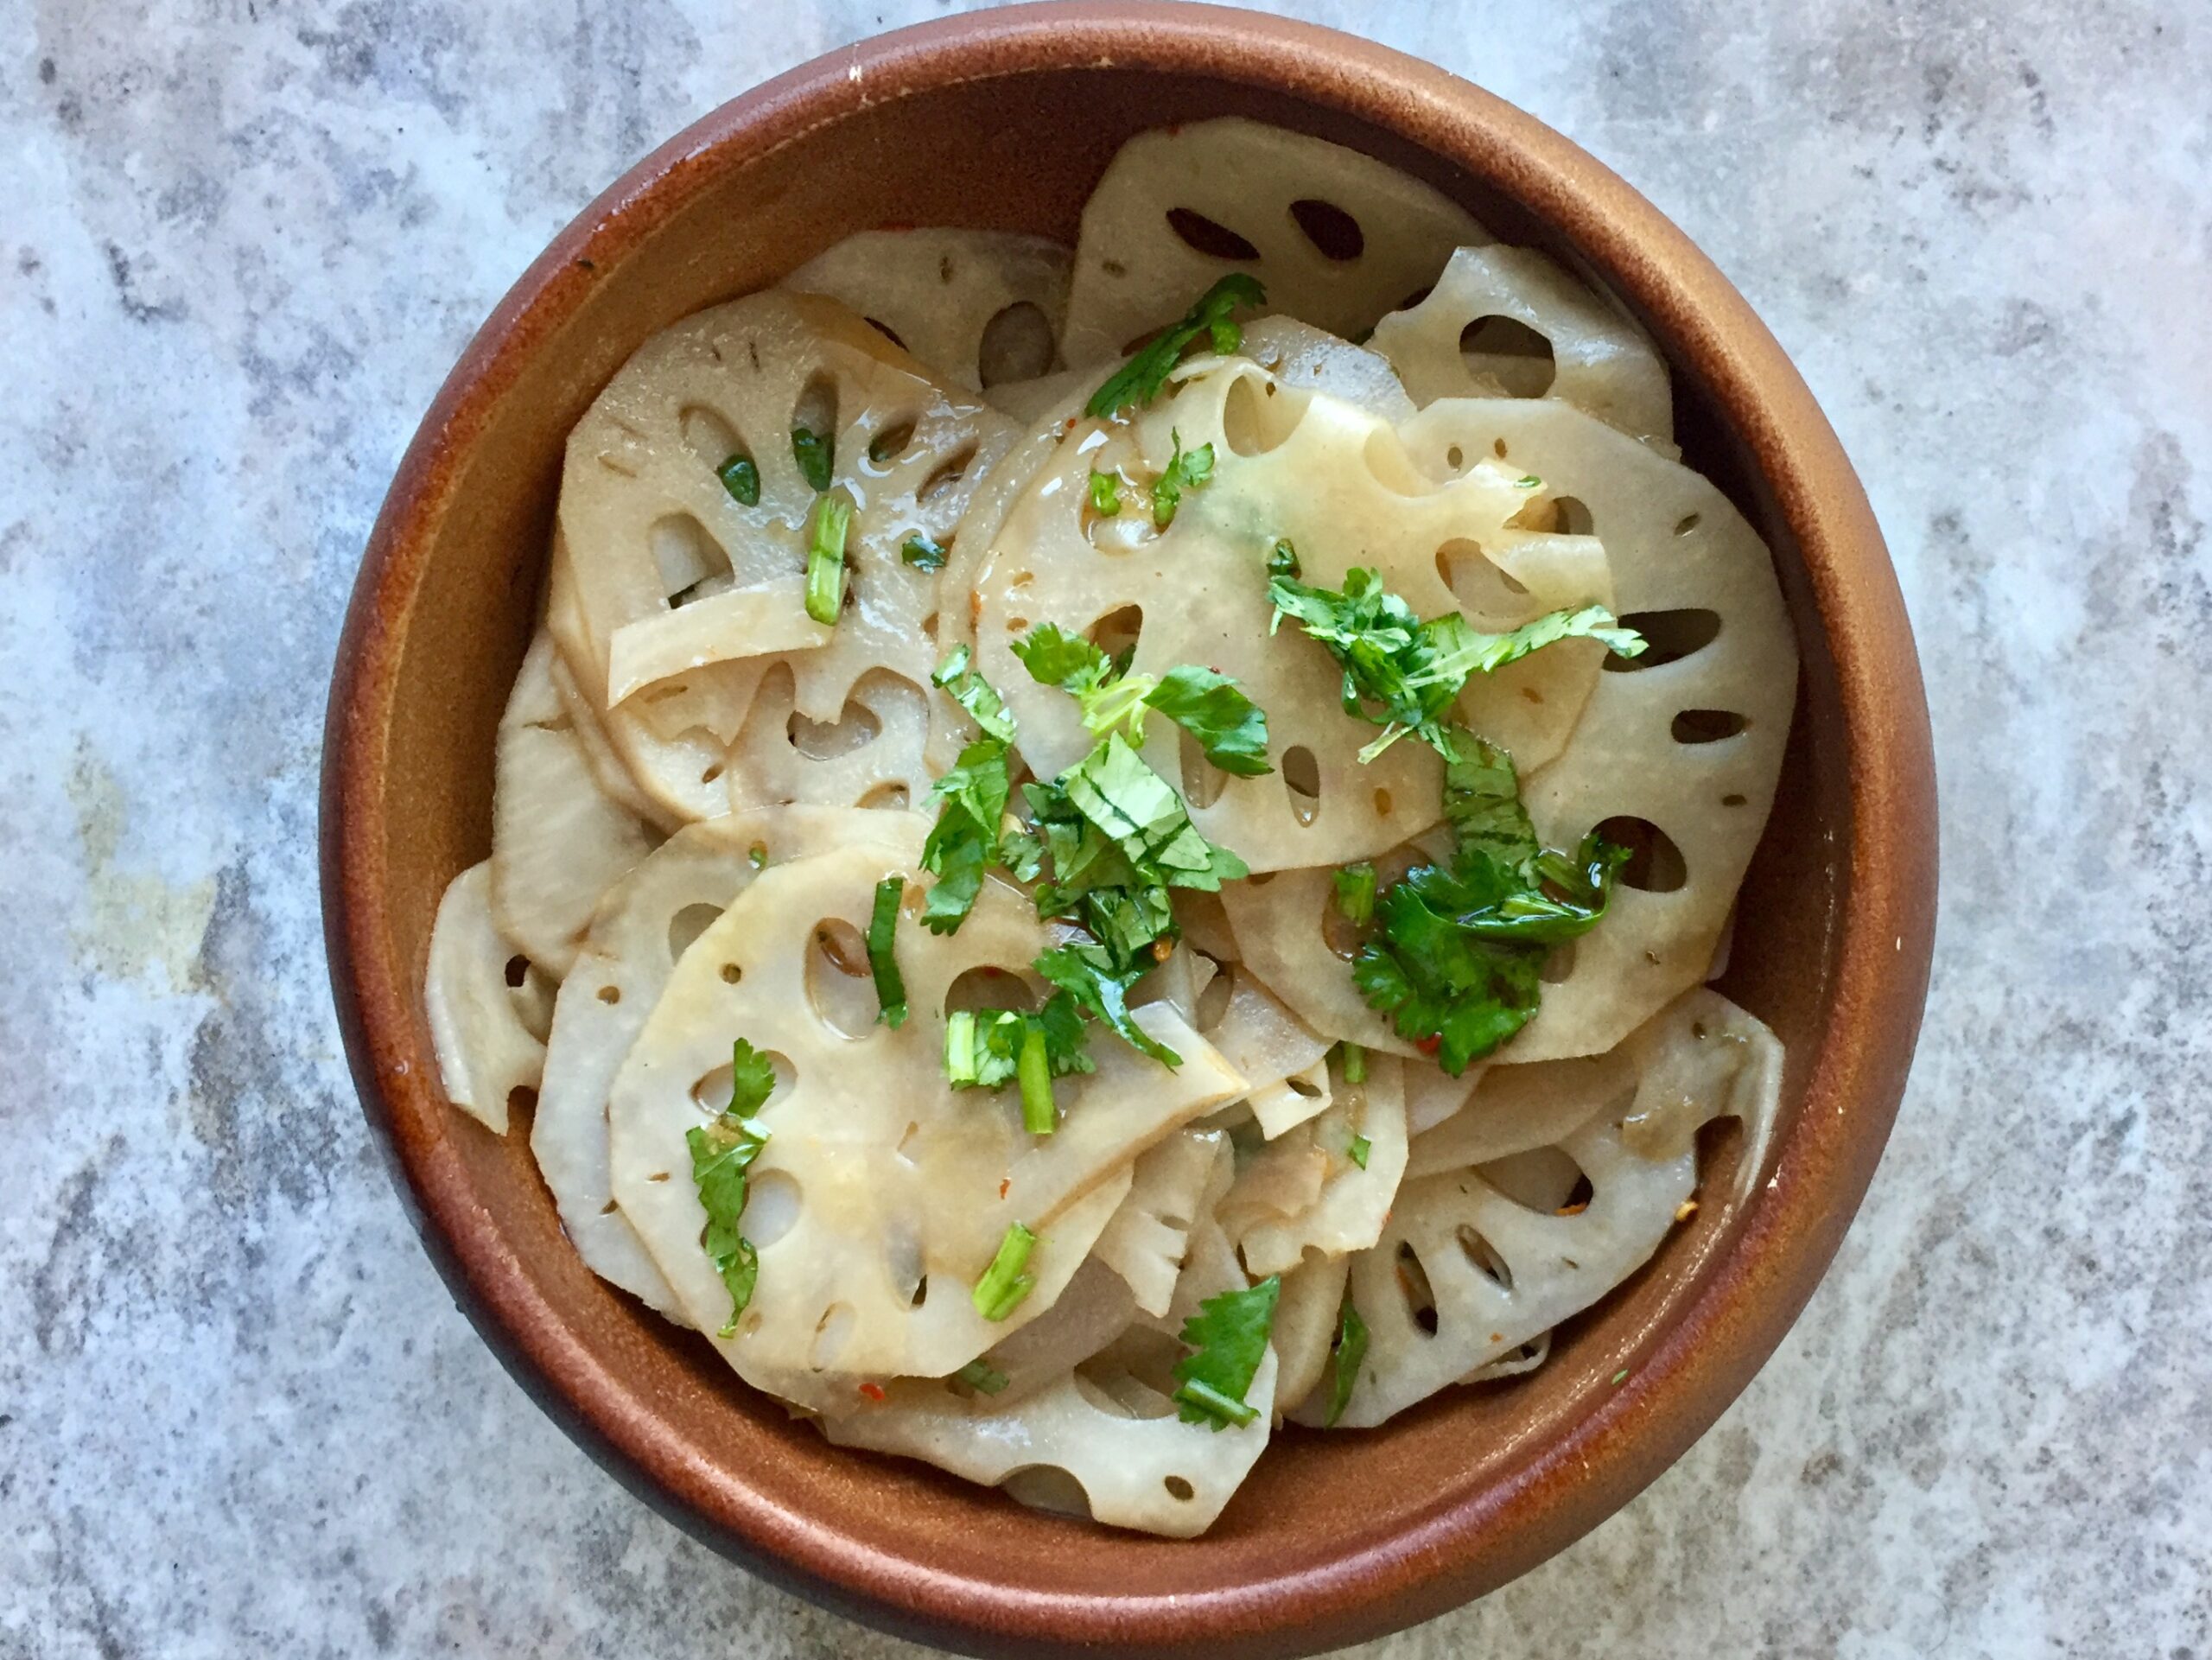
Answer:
[560, 292, 1013, 719]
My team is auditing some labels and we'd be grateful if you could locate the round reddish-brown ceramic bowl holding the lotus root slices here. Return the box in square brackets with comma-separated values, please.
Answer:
[323, 4, 1936, 1660]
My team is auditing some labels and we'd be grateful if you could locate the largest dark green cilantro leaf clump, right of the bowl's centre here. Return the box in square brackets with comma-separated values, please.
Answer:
[1351, 728, 1628, 1076]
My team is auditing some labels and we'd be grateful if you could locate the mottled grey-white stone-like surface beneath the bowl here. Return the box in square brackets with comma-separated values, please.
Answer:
[0, 0, 2212, 1660]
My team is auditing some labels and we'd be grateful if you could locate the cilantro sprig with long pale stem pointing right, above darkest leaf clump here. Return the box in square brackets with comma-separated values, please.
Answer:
[1268, 567, 1643, 761]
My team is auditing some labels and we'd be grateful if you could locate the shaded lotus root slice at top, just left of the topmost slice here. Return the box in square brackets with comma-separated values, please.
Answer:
[783, 228, 1071, 391]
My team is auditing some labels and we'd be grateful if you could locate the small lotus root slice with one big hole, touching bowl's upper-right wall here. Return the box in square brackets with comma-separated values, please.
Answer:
[1371, 244, 1675, 442]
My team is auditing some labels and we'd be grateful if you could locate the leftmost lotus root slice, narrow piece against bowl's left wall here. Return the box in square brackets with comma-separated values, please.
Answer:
[423, 859, 546, 1135]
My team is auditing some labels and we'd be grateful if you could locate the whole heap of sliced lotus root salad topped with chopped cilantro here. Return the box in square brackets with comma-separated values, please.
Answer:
[427, 119, 1796, 1536]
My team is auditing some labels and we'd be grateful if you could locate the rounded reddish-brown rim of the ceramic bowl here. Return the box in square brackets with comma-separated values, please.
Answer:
[321, 0, 1936, 1657]
